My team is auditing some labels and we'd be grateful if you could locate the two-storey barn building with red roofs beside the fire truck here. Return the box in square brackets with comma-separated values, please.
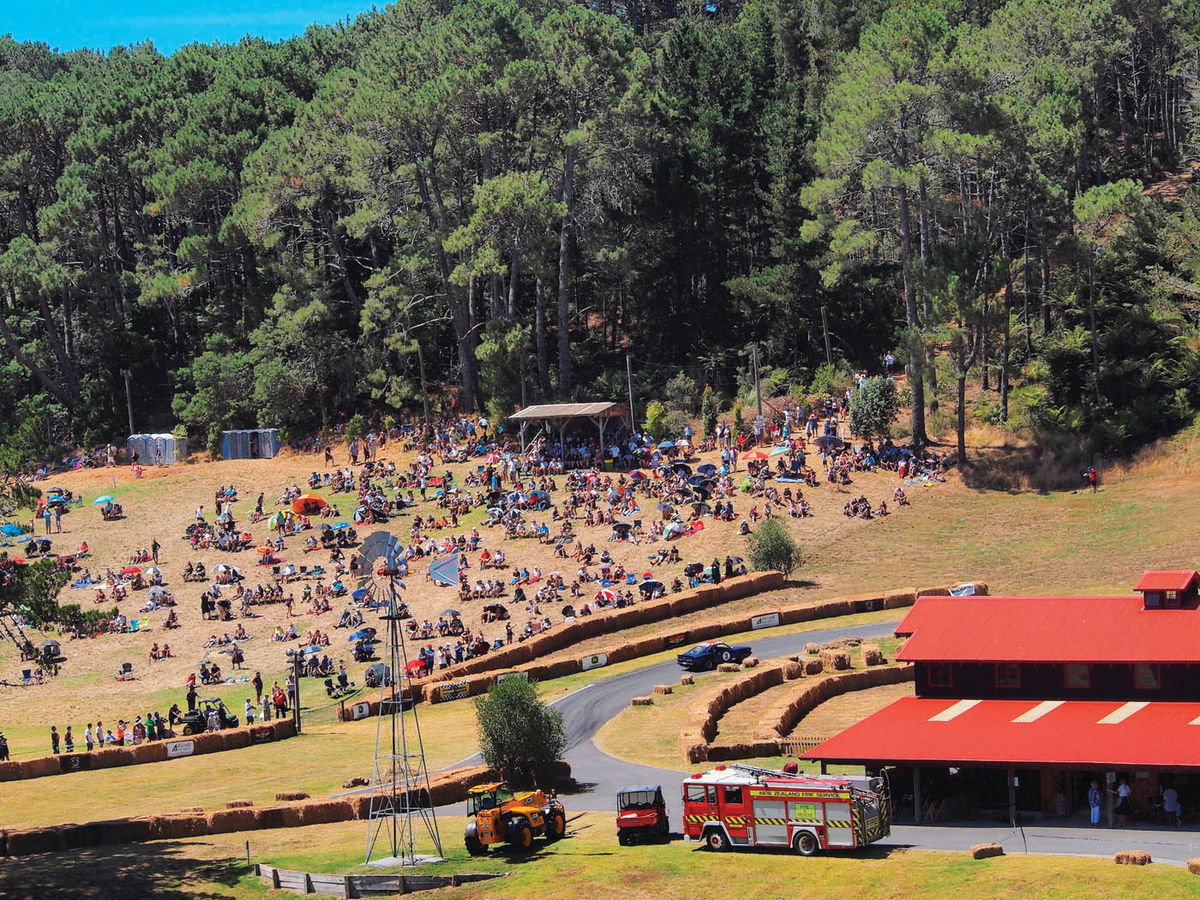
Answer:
[805, 570, 1200, 822]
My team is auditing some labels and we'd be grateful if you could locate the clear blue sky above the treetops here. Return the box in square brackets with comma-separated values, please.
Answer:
[0, 0, 385, 54]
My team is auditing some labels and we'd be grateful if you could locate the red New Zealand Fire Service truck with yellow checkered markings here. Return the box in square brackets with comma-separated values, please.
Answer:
[683, 763, 892, 857]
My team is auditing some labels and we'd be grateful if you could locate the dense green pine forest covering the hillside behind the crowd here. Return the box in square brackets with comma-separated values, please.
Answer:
[0, 0, 1200, 465]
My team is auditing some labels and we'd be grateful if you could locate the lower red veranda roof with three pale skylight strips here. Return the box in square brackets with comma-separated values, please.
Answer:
[803, 697, 1200, 769]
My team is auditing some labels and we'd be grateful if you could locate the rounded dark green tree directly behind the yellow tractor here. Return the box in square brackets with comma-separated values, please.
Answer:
[475, 677, 566, 787]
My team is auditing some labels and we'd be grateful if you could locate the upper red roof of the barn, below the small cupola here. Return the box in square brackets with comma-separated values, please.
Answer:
[896, 594, 1200, 667]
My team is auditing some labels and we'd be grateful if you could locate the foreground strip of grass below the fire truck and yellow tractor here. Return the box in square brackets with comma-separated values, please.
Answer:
[0, 816, 1200, 900]
